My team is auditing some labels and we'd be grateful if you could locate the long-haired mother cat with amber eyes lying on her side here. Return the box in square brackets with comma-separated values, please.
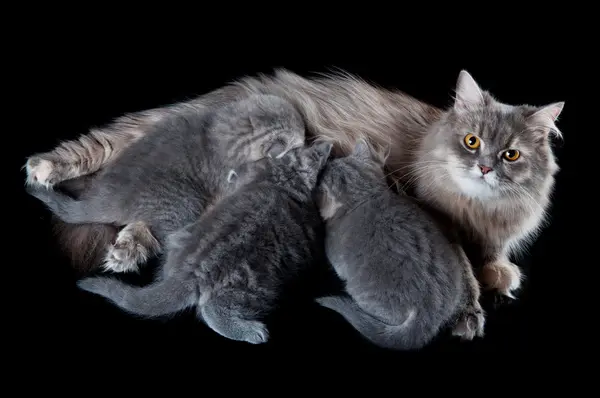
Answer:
[26, 70, 564, 296]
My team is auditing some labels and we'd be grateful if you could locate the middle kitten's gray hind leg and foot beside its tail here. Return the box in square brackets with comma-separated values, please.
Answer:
[200, 289, 269, 344]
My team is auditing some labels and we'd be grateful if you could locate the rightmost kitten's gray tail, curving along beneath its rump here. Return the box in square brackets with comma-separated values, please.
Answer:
[316, 296, 422, 350]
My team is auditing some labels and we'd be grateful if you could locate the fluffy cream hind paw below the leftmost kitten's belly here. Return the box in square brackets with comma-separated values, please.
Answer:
[103, 221, 161, 272]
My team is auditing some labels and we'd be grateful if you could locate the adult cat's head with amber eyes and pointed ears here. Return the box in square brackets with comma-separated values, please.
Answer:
[413, 71, 564, 200]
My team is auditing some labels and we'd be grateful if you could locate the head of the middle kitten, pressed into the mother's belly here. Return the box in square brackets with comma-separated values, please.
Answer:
[228, 142, 333, 192]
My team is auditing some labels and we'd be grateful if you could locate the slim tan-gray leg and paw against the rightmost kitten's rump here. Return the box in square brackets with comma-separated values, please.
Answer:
[452, 245, 485, 340]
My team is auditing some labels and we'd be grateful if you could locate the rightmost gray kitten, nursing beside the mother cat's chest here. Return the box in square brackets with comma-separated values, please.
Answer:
[317, 140, 484, 350]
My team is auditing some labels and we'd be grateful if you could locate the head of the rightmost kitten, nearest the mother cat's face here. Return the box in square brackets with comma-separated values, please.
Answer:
[316, 139, 387, 220]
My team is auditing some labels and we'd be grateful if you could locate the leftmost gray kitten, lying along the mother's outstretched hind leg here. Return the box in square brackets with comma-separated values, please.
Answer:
[30, 95, 305, 272]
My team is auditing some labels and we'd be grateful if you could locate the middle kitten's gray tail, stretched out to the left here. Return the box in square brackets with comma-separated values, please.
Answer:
[77, 277, 198, 317]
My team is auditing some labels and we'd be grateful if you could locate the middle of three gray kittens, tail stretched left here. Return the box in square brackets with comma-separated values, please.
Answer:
[78, 143, 332, 344]
